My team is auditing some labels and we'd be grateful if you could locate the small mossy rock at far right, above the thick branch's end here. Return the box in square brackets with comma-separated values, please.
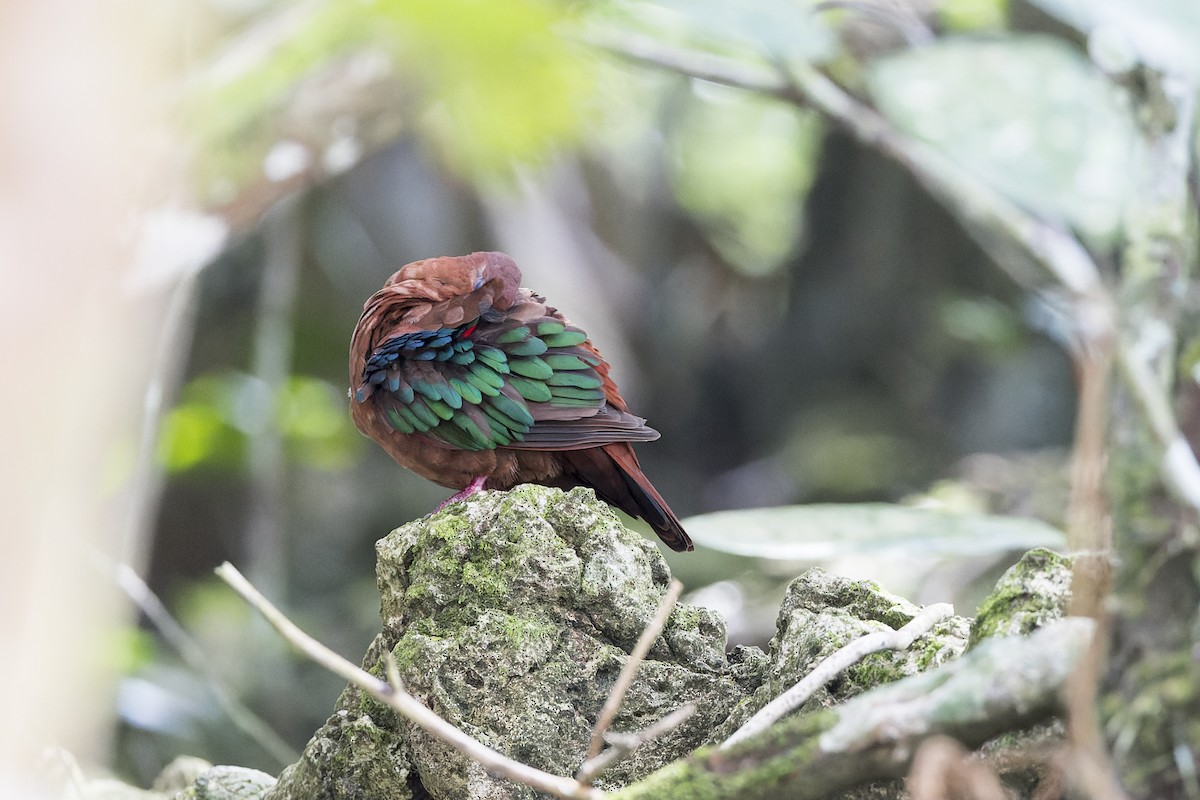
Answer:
[970, 547, 1072, 648]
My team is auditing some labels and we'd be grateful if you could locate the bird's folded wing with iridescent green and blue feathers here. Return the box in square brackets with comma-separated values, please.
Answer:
[354, 287, 659, 450]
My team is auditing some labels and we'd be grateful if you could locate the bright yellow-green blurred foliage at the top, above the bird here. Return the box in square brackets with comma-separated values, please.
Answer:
[188, 0, 592, 185]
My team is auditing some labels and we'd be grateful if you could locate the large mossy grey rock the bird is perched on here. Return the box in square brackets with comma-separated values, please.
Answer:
[270, 486, 763, 800]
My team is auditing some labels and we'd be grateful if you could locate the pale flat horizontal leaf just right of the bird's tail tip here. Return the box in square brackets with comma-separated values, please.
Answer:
[684, 503, 1067, 561]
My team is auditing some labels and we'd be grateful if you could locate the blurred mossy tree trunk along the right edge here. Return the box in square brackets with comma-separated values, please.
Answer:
[1100, 71, 1200, 798]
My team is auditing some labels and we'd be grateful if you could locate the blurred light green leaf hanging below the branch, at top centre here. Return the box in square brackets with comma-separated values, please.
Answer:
[672, 86, 820, 275]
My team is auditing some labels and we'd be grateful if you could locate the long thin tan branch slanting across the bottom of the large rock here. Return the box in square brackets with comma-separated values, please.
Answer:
[216, 561, 606, 800]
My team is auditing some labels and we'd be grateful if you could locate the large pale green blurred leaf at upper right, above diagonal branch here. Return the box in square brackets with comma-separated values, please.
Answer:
[870, 36, 1134, 243]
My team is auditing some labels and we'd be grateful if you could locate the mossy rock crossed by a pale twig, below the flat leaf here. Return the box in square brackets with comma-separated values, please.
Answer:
[721, 567, 971, 735]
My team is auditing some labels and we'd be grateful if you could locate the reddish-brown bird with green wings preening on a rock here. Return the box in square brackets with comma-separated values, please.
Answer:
[349, 252, 692, 552]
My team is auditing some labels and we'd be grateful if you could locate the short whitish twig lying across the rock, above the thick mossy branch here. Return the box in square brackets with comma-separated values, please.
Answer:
[721, 603, 954, 750]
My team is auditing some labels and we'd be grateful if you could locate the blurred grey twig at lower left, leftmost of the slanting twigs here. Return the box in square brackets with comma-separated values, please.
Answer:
[114, 564, 300, 766]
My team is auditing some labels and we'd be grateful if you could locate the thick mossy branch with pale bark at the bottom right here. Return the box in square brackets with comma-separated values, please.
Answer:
[611, 618, 1094, 800]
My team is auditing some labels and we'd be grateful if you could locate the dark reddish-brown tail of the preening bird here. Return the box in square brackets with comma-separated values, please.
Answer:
[559, 441, 692, 552]
